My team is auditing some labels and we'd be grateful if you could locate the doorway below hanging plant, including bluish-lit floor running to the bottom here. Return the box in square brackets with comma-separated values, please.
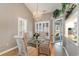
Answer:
[53, 18, 63, 56]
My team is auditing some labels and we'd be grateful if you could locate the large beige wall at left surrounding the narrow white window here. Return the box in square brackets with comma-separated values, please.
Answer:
[0, 3, 33, 51]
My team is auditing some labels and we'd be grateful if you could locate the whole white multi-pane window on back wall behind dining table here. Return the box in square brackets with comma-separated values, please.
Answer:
[35, 21, 50, 39]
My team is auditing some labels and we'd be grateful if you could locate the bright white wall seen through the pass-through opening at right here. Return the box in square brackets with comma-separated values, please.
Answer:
[65, 12, 78, 38]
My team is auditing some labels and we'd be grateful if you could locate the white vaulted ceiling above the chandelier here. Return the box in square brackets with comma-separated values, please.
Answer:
[25, 3, 62, 14]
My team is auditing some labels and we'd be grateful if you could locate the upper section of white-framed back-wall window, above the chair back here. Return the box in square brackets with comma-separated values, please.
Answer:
[35, 21, 49, 32]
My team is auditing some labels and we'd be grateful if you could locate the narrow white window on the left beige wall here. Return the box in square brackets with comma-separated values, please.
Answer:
[18, 18, 27, 36]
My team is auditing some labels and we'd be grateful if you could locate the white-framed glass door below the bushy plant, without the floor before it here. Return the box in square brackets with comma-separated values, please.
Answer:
[53, 19, 63, 43]
